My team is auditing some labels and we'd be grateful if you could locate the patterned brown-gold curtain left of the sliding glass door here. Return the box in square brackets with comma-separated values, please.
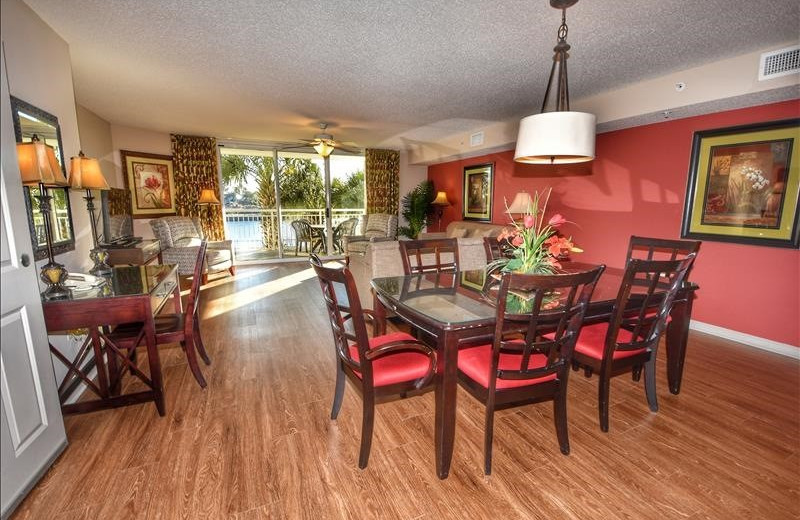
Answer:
[170, 134, 225, 240]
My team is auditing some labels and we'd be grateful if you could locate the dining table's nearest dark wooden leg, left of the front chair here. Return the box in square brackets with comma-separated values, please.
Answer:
[434, 331, 458, 479]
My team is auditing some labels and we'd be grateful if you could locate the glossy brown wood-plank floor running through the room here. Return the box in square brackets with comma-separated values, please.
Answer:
[7, 263, 800, 520]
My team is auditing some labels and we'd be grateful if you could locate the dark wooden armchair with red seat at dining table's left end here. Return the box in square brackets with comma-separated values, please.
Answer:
[309, 254, 436, 469]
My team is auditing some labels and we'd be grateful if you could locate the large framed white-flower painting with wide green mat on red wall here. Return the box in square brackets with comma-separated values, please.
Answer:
[681, 119, 800, 248]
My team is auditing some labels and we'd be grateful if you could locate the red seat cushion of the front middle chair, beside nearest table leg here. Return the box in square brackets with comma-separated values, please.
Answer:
[458, 345, 556, 390]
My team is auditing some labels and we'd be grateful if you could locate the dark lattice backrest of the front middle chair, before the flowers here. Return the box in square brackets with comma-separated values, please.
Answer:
[489, 265, 605, 391]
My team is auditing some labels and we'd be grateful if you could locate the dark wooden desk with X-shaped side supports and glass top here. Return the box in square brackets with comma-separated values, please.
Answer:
[42, 265, 181, 416]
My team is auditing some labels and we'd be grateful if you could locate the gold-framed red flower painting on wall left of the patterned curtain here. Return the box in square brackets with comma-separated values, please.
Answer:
[120, 150, 175, 218]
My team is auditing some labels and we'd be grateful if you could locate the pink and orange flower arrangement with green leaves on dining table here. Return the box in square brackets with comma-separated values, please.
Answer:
[487, 188, 583, 274]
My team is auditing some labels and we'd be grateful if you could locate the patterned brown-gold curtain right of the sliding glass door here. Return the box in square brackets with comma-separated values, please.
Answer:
[364, 148, 400, 215]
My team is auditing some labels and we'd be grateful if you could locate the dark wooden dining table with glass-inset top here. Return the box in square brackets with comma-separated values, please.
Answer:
[371, 262, 698, 479]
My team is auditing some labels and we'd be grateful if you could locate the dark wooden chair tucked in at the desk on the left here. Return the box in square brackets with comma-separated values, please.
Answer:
[109, 240, 211, 388]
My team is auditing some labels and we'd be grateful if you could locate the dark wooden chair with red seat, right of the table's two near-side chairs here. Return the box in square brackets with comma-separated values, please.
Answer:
[572, 252, 696, 432]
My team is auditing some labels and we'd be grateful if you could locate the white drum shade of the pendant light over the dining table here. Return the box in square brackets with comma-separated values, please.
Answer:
[514, 111, 597, 164]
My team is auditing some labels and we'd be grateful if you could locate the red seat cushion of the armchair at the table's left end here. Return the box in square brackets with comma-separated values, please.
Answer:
[350, 332, 430, 386]
